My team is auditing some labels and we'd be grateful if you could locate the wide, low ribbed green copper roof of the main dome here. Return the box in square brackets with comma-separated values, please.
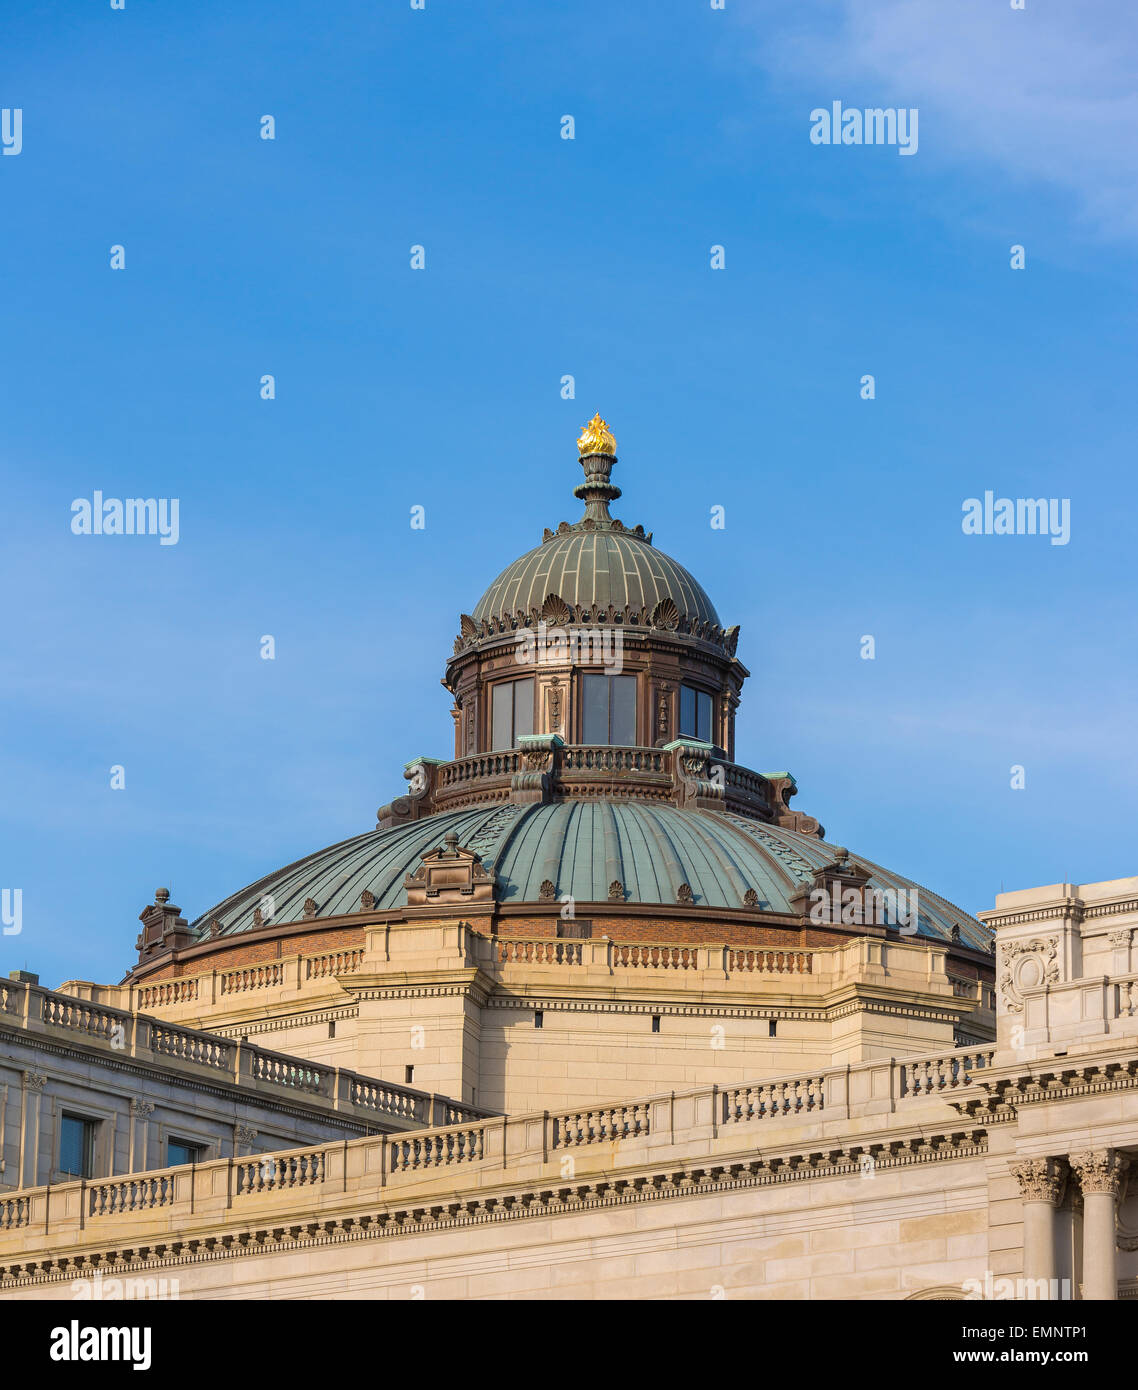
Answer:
[193, 799, 991, 951]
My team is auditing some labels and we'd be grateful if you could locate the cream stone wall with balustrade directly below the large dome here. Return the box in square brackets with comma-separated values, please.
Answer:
[60, 917, 995, 1113]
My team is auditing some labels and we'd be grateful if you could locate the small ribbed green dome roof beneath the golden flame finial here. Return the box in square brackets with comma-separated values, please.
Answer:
[472, 530, 721, 627]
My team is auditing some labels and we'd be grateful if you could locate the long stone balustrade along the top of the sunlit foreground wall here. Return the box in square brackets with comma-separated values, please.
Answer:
[0, 1049, 993, 1252]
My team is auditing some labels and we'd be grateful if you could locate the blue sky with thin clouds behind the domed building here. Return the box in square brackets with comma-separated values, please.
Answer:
[0, 0, 1138, 983]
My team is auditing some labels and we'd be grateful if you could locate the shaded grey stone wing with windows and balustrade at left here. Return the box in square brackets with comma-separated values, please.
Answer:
[0, 981, 481, 1191]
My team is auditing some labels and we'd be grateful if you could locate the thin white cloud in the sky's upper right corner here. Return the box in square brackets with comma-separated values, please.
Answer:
[757, 0, 1138, 238]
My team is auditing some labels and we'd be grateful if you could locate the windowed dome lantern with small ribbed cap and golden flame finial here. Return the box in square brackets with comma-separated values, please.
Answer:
[443, 414, 748, 758]
